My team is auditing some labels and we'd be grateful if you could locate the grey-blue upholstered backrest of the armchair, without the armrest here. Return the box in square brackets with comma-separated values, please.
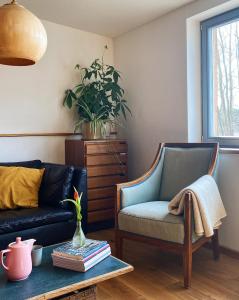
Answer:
[159, 143, 218, 201]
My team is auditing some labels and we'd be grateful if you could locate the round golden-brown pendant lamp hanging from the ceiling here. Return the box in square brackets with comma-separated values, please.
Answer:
[0, 0, 47, 66]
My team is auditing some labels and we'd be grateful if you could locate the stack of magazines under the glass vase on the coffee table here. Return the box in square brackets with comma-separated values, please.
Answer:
[51, 239, 111, 272]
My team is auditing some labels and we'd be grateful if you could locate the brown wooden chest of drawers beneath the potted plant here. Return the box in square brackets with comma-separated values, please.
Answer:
[65, 140, 127, 229]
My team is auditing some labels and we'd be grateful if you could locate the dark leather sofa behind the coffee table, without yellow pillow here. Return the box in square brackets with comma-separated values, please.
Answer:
[0, 160, 87, 250]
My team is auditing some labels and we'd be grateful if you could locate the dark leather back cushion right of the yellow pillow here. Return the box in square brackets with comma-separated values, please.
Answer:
[39, 164, 74, 207]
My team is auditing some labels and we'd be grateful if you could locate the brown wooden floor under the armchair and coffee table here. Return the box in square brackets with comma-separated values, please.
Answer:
[90, 230, 239, 300]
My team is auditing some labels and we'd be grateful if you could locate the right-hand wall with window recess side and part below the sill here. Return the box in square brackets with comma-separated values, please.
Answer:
[114, 0, 239, 251]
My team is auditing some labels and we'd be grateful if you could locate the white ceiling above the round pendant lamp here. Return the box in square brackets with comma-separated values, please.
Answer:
[0, 0, 195, 37]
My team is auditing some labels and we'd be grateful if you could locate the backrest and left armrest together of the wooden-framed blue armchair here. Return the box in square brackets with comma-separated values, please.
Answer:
[117, 143, 219, 209]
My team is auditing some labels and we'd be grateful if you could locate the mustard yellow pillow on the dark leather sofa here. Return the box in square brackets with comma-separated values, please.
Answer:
[0, 167, 44, 209]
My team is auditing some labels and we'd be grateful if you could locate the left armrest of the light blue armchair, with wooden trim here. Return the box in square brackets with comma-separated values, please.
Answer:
[116, 144, 164, 214]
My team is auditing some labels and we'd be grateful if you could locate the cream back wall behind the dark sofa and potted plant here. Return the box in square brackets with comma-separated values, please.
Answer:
[0, 21, 113, 162]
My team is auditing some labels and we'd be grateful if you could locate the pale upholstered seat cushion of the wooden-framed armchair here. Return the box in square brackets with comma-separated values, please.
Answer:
[118, 201, 199, 244]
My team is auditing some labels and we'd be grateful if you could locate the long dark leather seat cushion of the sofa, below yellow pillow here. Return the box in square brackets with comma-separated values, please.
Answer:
[0, 207, 74, 234]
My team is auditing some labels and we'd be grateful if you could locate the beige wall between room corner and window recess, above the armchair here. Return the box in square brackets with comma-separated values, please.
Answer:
[114, 0, 231, 177]
